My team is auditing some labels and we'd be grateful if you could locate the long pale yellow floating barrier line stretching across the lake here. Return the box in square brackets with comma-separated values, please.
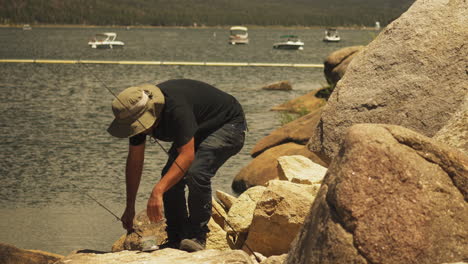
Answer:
[0, 59, 323, 68]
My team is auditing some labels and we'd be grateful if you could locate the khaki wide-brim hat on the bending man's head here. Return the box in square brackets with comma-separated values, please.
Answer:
[107, 84, 164, 138]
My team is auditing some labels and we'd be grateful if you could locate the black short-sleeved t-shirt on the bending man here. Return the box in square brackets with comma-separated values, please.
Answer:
[130, 79, 245, 147]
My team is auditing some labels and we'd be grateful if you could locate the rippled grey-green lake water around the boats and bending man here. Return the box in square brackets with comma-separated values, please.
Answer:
[0, 28, 377, 254]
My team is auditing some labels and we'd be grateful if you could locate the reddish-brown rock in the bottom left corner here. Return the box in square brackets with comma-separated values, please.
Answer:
[0, 243, 64, 264]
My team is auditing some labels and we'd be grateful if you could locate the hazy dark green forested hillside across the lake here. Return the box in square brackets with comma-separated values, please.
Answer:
[0, 0, 414, 26]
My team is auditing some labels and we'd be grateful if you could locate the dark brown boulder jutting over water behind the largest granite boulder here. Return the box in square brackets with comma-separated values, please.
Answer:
[323, 46, 364, 86]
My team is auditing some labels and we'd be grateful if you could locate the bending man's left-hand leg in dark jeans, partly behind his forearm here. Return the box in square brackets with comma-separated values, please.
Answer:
[161, 148, 188, 249]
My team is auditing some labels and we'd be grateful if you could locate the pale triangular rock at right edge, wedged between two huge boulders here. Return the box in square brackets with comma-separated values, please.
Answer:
[433, 96, 468, 154]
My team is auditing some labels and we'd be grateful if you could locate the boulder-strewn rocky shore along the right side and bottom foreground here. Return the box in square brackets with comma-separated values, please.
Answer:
[0, 0, 468, 264]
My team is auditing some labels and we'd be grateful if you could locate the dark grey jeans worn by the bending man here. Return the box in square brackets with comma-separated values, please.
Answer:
[162, 124, 246, 241]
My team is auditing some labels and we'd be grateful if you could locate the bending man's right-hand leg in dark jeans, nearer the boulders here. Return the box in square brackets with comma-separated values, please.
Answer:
[181, 124, 245, 251]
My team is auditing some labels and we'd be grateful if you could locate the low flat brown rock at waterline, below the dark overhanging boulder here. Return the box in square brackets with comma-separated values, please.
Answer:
[271, 89, 327, 113]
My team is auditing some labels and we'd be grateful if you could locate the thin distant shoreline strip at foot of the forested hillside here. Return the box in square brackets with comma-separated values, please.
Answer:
[0, 24, 375, 30]
